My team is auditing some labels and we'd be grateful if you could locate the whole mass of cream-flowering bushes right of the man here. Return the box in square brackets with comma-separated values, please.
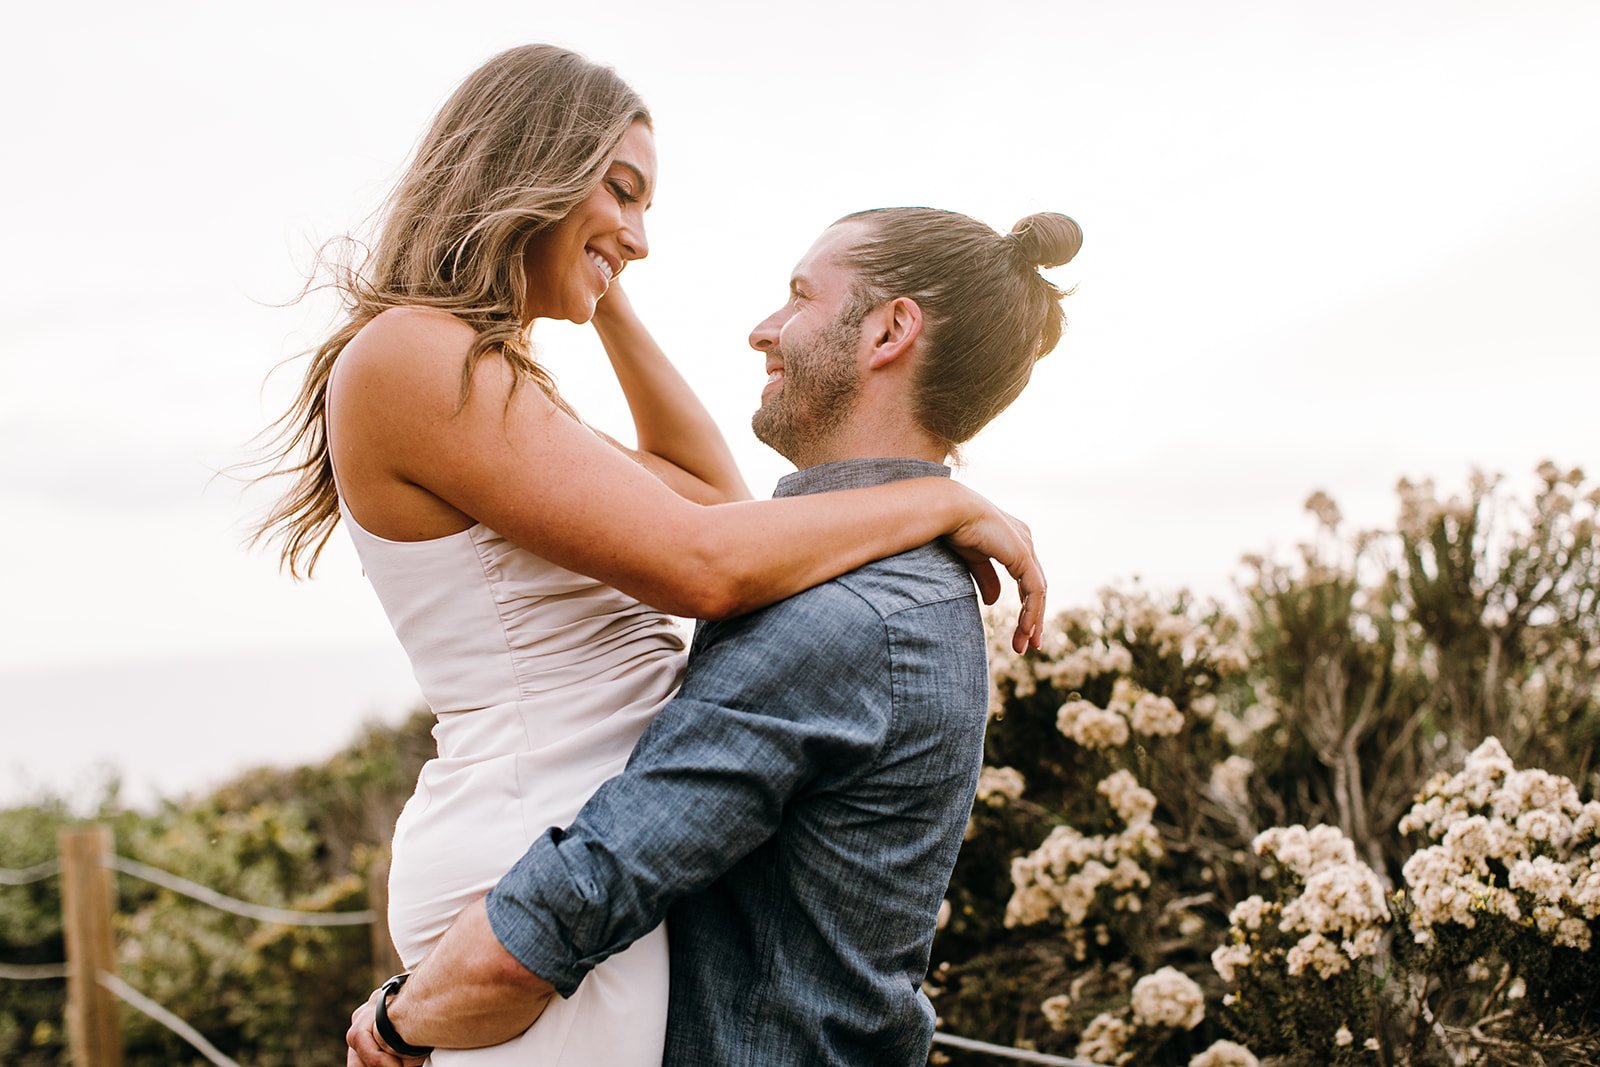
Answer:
[930, 464, 1600, 1067]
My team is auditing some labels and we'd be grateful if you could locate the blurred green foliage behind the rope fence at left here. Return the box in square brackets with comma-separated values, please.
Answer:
[0, 712, 434, 1067]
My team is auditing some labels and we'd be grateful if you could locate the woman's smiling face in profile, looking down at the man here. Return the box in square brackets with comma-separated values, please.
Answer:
[523, 122, 656, 323]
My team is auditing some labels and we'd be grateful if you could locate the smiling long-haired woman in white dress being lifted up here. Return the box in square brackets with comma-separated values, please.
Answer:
[262, 46, 1043, 1067]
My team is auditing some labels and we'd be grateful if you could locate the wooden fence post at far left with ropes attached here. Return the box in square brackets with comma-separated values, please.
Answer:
[59, 825, 122, 1067]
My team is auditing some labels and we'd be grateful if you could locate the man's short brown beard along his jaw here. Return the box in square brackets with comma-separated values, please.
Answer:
[750, 315, 861, 467]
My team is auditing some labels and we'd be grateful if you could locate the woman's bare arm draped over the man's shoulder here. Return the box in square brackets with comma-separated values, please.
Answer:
[328, 303, 1045, 651]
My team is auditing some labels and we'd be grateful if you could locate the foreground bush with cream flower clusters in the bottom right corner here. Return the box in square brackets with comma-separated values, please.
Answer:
[1211, 748, 1600, 1064]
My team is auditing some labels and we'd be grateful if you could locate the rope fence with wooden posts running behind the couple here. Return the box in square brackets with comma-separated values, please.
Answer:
[0, 825, 1094, 1067]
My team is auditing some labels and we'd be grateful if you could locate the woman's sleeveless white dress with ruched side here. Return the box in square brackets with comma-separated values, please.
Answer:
[339, 499, 685, 1067]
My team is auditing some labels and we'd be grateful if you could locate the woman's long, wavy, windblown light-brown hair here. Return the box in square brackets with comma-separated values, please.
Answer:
[253, 45, 650, 577]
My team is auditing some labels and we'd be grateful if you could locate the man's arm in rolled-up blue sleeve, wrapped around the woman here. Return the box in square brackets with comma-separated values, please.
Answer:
[352, 584, 890, 1067]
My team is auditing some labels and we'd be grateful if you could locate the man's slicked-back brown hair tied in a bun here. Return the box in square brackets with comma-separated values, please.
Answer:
[840, 208, 1083, 453]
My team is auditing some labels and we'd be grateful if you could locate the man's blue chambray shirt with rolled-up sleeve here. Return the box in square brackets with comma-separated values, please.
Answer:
[488, 459, 989, 1067]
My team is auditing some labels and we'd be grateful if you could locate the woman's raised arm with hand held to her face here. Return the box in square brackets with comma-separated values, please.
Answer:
[594, 282, 750, 504]
